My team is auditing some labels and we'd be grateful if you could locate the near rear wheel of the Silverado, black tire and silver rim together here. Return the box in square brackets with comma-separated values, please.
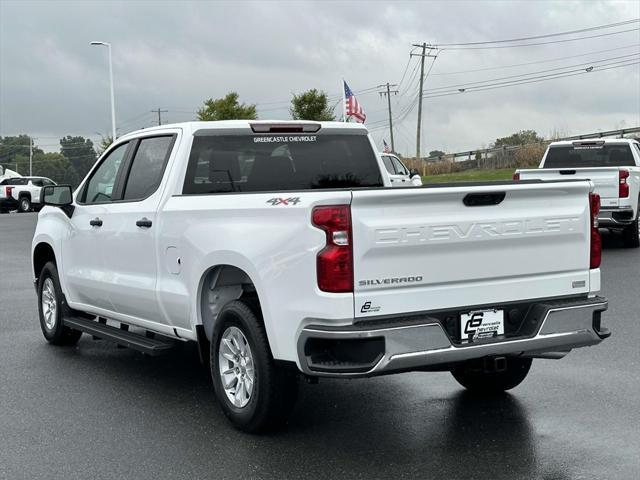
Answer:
[210, 300, 298, 432]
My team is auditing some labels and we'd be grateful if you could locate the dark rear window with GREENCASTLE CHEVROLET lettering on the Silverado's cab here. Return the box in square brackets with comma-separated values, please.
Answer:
[183, 134, 382, 194]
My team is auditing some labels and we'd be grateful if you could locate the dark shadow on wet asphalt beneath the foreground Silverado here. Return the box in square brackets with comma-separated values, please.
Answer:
[50, 336, 569, 480]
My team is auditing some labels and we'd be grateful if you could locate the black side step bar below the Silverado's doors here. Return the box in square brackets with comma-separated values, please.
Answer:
[63, 317, 174, 356]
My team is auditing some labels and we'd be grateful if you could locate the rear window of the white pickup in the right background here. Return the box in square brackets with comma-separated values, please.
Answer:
[544, 145, 635, 168]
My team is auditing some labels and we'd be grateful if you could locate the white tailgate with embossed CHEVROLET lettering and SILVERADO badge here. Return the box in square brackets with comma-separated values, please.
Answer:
[351, 181, 590, 317]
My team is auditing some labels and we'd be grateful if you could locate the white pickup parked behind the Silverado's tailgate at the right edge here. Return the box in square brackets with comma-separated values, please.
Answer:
[514, 139, 640, 248]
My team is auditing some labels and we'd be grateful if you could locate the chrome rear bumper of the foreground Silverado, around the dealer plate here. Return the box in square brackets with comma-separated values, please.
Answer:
[298, 297, 610, 377]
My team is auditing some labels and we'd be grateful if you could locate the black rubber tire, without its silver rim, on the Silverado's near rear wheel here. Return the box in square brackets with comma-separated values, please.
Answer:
[210, 300, 298, 433]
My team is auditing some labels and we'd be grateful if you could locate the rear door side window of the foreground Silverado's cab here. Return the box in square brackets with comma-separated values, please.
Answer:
[123, 136, 174, 200]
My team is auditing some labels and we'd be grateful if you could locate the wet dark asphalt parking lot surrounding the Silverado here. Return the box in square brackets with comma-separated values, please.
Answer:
[0, 214, 640, 480]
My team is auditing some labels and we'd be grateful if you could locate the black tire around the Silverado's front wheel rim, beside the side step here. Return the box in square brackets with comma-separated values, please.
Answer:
[38, 262, 82, 345]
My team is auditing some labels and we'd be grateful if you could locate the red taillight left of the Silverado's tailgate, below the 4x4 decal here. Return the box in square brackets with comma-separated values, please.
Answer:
[311, 205, 353, 293]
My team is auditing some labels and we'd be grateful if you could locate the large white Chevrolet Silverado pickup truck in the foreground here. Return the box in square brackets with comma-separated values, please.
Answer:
[32, 121, 610, 431]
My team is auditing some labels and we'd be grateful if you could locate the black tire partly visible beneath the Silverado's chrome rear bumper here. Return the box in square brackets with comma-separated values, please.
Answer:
[451, 357, 532, 394]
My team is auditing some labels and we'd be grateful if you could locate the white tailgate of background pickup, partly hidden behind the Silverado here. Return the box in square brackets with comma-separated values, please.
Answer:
[519, 167, 620, 207]
